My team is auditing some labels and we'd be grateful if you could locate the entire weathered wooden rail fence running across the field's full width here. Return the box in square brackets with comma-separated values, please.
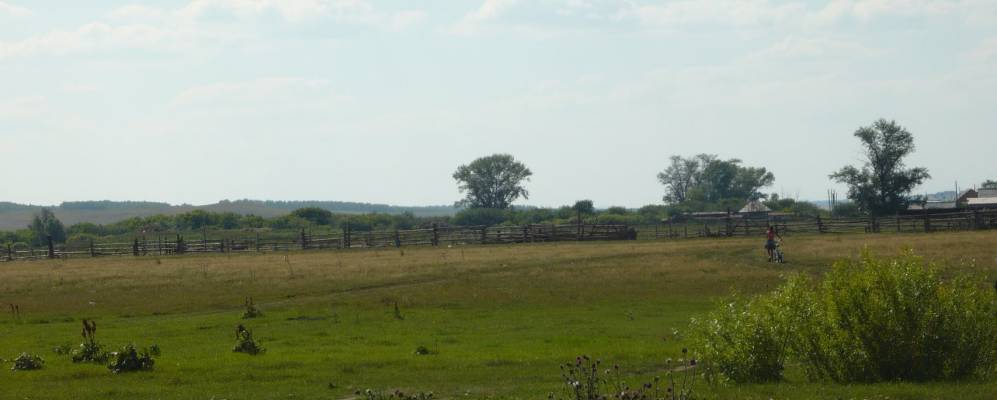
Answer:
[0, 210, 997, 262]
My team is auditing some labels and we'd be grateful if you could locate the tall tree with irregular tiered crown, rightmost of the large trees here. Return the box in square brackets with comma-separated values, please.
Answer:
[831, 119, 931, 216]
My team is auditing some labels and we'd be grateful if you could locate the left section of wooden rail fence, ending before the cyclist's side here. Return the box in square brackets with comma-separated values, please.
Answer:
[0, 224, 636, 261]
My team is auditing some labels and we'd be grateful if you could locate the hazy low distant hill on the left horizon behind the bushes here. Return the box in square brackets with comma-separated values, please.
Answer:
[0, 200, 457, 231]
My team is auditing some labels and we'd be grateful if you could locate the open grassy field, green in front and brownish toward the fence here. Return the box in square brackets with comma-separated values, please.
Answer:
[0, 231, 997, 400]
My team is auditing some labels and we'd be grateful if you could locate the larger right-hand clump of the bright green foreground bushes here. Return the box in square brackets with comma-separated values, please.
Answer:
[779, 251, 997, 382]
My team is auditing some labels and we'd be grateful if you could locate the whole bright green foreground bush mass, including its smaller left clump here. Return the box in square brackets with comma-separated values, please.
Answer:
[697, 252, 997, 382]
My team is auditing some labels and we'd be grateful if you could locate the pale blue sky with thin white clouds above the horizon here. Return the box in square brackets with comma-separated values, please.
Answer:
[0, 0, 997, 207]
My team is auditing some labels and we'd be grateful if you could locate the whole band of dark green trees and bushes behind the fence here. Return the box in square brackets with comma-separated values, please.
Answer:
[0, 119, 984, 245]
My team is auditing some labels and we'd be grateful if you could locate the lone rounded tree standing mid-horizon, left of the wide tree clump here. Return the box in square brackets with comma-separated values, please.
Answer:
[453, 154, 533, 209]
